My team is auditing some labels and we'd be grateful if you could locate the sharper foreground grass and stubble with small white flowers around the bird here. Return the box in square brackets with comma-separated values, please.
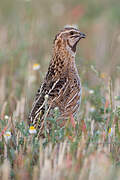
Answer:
[0, 62, 120, 180]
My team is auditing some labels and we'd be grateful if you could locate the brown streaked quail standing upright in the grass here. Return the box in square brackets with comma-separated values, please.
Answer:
[28, 26, 86, 136]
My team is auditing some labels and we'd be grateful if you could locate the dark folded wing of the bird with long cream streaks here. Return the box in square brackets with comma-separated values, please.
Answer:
[29, 77, 68, 125]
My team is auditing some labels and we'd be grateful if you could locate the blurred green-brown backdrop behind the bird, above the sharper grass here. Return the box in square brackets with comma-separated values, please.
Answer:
[0, 0, 120, 114]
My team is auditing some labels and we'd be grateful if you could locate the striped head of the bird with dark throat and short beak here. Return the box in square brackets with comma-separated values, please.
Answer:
[54, 27, 86, 55]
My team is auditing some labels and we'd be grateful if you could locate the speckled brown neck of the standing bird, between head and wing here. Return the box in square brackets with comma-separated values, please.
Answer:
[46, 44, 77, 81]
